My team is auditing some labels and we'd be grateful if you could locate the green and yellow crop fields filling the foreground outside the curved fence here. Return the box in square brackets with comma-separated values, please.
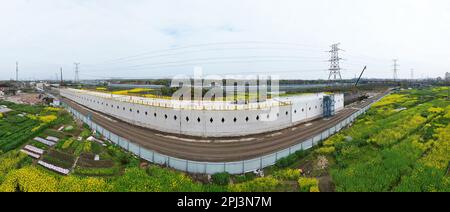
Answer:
[0, 87, 450, 192]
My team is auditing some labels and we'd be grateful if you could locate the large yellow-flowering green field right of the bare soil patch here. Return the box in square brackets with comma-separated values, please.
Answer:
[322, 87, 450, 191]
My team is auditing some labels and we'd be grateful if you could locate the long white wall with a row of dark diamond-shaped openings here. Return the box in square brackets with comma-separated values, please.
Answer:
[61, 89, 343, 137]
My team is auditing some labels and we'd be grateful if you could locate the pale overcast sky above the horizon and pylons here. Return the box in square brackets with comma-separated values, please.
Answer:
[0, 0, 450, 80]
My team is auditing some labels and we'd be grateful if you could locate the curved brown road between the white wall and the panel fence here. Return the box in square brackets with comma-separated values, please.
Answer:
[63, 94, 383, 162]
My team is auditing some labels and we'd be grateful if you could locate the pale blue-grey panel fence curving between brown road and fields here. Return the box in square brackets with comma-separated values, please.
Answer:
[64, 93, 386, 174]
